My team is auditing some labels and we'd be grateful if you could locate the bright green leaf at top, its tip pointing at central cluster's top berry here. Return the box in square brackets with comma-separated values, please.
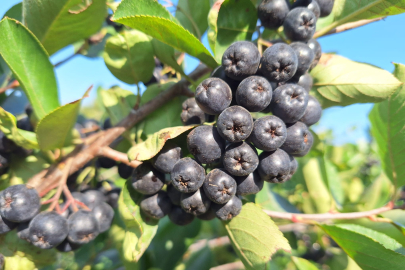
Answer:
[113, 0, 218, 68]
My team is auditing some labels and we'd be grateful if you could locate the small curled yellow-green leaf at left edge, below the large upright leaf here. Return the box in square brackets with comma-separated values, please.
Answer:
[0, 107, 39, 149]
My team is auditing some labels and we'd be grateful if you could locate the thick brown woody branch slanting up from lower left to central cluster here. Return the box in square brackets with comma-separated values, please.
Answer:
[28, 65, 211, 194]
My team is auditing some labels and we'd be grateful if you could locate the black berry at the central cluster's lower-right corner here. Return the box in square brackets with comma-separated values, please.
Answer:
[257, 149, 290, 183]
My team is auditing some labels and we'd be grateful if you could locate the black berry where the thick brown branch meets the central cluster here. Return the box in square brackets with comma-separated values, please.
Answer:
[195, 78, 232, 115]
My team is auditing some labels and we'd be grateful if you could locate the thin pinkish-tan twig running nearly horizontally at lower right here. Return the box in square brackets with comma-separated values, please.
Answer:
[263, 202, 396, 222]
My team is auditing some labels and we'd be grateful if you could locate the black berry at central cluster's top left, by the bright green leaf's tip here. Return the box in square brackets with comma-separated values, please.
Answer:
[222, 41, 260, 81]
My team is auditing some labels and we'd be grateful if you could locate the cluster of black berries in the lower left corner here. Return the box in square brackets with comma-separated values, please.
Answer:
[0, 185, 114, 252]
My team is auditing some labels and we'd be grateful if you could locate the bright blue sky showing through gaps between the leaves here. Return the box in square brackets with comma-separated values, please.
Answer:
[0, 0, 405, 144]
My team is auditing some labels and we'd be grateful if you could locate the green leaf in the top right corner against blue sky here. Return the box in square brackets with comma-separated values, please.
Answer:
[316, 0, 405, 36]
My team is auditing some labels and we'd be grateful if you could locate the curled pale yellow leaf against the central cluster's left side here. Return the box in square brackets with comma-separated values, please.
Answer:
[128, 125, 196, 161]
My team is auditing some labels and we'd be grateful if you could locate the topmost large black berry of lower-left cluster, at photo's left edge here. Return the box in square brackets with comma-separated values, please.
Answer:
[0, 185, 41, 222]
